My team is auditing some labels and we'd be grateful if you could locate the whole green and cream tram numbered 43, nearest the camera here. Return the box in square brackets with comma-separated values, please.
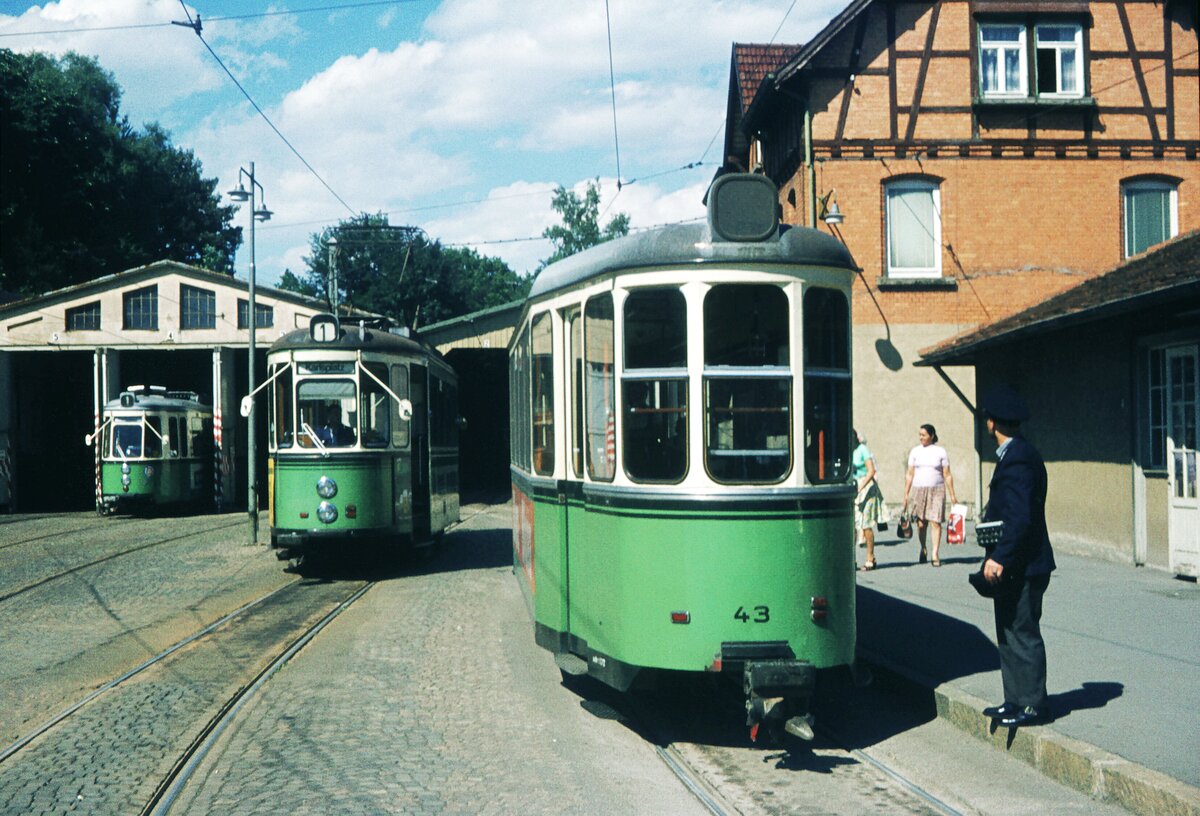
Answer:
[509, 174, 856, 742]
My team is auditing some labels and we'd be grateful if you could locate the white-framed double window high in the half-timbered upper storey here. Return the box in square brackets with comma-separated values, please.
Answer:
[979, 23, 1084, 98]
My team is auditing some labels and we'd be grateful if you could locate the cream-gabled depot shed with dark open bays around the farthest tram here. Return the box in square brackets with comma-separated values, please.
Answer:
[0, 260, 367, 512]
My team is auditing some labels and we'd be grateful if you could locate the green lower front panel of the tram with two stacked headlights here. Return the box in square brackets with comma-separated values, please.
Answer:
[271, 451, 412, 535]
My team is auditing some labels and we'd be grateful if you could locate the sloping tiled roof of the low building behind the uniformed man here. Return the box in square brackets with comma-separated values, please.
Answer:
[917, 230, 1200, 366]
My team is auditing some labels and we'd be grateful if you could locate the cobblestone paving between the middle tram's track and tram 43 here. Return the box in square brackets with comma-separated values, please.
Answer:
[173, 505, 707, 815]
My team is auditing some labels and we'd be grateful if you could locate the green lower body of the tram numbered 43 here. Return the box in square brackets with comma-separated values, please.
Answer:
[516, 479, 856, 671]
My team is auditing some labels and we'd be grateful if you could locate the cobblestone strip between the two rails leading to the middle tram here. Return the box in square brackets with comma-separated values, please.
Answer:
[0, 582, 361, 816]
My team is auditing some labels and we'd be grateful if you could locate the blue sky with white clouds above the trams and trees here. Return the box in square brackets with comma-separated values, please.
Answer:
[0, 0, 846, 283]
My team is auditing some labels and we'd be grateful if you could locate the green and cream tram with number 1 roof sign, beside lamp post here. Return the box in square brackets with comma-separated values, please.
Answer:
[262, 314, 458, 560]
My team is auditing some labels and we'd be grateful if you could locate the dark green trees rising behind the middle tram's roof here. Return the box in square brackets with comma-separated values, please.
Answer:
[295, 214, 532, 326]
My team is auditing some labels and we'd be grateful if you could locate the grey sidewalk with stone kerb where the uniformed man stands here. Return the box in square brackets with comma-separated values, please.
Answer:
[856, 525, 1200, 816]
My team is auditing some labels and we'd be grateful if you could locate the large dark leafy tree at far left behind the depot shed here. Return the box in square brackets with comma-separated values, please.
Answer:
[0, 49, 241, 295]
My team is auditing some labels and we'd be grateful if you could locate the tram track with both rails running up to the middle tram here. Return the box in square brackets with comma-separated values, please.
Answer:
[0, 578, 377, 814]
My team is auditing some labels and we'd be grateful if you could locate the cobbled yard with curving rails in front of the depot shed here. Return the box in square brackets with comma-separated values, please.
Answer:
[0, 514, 294, 748]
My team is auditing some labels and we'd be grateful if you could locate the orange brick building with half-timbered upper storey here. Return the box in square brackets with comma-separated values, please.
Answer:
[725, 0, 1200, 523]
